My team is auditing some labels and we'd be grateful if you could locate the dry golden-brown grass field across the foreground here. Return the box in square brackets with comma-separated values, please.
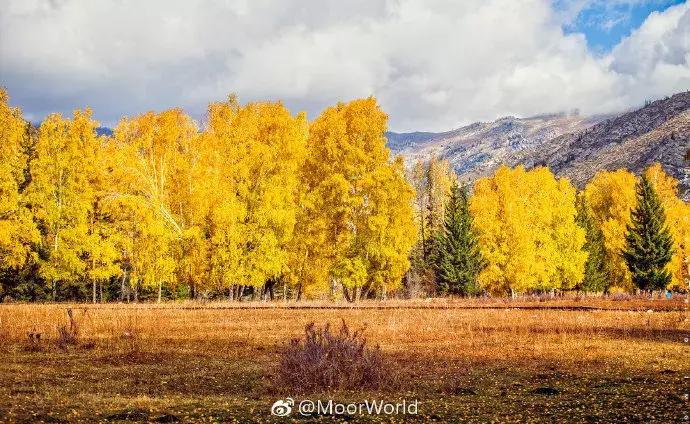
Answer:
[0, 299, 690, 422]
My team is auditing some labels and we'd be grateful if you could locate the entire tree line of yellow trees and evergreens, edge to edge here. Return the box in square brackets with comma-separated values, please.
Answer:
[0, 91, 690, 302]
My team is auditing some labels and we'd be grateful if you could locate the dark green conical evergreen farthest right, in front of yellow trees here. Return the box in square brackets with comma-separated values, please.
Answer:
[623, 175, 673, 290]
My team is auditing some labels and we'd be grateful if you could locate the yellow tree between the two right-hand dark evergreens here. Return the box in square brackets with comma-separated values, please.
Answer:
[584, 170, 637, 290]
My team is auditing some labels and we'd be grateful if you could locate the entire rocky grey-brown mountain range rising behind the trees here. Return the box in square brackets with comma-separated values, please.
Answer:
[387, 91, 690, 199]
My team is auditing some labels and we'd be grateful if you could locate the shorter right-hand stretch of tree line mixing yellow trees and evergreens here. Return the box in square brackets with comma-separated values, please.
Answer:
[410, 158, 690, 296]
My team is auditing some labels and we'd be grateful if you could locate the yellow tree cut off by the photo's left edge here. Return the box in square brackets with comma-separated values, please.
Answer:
[0, 88, 38, 269]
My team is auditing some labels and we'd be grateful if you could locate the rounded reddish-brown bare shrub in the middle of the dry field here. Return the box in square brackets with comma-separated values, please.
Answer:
[278, 321, 391, 391]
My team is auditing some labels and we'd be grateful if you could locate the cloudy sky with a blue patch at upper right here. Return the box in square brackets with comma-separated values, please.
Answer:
[0, 0, 690, 131]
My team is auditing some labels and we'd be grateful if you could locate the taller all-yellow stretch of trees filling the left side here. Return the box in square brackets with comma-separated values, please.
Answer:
[0, 92, 416, 301]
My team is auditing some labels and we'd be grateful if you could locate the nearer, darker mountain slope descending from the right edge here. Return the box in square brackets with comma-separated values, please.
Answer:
[506, 91, 690, 199]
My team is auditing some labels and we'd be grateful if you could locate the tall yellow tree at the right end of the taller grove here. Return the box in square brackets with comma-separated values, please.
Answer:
[304, 97, 416, 300]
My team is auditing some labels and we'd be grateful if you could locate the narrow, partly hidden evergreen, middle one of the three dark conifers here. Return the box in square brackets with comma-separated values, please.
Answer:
[577, 196, 609, 292]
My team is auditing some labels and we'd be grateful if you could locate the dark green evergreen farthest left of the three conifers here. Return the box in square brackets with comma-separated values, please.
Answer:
[433, 183, 486, 295]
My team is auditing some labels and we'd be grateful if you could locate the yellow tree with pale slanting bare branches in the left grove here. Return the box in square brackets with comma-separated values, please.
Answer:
[113, 109, 198, 301]
